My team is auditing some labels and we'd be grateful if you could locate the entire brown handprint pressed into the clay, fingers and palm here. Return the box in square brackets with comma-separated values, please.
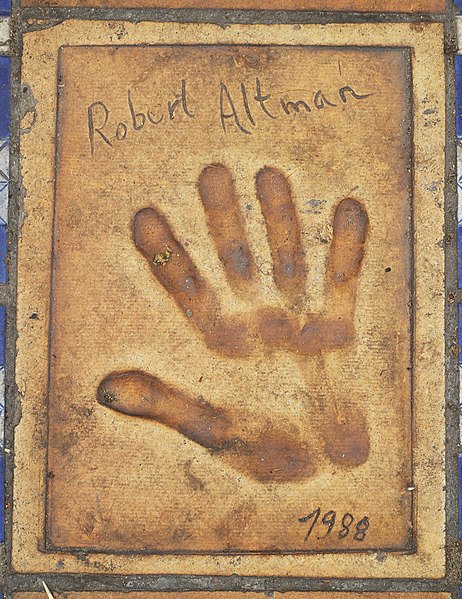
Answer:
[97, 165, 369, 482]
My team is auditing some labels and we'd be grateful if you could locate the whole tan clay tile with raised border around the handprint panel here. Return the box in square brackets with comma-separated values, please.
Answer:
[15, 23, 444, 577]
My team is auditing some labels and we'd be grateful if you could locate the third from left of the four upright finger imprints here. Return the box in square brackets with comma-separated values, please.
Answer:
[256, 167, 306, 304]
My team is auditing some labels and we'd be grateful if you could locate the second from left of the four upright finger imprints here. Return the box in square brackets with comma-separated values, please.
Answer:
[198, 164, 256, 291]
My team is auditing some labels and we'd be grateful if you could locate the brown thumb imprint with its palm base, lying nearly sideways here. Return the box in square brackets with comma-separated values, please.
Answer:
[97, 370, 315, 482]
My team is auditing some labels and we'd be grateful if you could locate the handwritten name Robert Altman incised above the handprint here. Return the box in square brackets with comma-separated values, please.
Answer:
[88, 78, 373, 156]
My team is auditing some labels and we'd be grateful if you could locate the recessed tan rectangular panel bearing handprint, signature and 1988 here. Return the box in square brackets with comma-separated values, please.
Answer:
[48, 46, 413, 553]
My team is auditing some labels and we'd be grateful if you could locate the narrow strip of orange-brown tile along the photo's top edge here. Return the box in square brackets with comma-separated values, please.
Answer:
[19, 0, 445, 13]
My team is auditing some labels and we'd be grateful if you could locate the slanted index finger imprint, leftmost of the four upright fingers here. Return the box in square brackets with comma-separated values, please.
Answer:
[133, 208, 219, 333]
